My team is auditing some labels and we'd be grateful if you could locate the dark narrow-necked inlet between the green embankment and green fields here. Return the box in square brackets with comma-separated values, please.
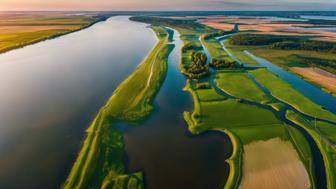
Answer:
[120, 28, 232, 189]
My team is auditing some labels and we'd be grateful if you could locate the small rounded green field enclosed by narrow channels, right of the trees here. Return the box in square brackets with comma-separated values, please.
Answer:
[215, 70, 272, 104]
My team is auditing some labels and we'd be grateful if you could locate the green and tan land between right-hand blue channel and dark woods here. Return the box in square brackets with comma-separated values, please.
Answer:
[225, 36, 336, 96]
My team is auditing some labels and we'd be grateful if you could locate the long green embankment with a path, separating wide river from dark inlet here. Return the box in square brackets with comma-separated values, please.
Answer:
[62, 27, 174, 189]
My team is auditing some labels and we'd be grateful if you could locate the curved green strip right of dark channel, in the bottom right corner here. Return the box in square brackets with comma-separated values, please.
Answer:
[286, 111, 336, 189]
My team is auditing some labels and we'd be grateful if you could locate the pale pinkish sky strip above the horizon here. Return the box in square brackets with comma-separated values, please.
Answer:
[0, 0, 336, 10]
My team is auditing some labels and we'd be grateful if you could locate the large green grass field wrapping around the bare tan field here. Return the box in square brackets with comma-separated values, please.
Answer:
[184, 75, 315, 188]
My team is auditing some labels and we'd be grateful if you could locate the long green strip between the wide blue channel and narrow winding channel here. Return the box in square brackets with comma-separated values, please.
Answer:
[249, 68, 336, 122]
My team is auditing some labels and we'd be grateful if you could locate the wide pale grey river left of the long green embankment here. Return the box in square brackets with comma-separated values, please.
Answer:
[0, 17, 156, 189]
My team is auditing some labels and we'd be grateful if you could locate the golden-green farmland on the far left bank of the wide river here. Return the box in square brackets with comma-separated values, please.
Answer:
[0, 12, 109, 54]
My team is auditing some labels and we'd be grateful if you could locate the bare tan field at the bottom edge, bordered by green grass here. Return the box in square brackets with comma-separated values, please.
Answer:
[240, 138, 310, 189]
